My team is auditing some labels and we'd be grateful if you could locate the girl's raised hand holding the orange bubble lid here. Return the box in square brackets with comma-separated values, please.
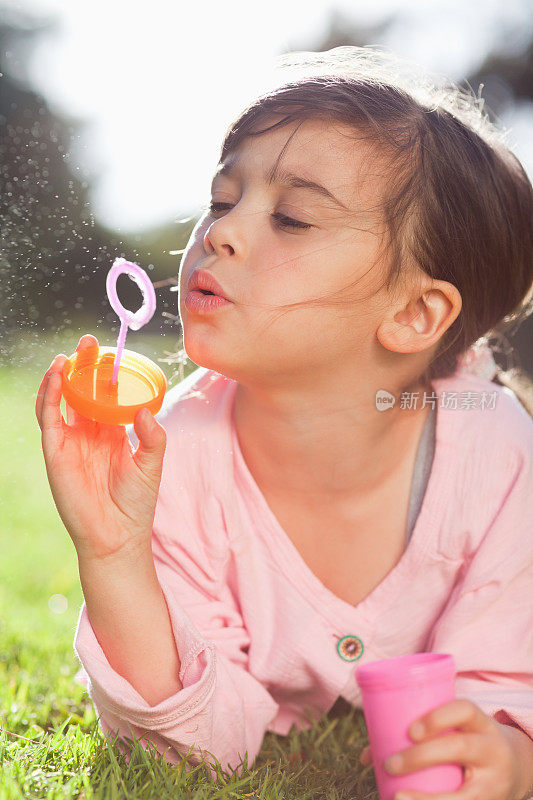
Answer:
[35, 335, 166, 559]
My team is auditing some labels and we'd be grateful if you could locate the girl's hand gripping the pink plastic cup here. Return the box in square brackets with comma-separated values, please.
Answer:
[360, 699, 522, 800]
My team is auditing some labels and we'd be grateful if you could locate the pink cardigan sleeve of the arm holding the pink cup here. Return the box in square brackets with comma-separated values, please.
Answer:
[426, 440, 533, 739]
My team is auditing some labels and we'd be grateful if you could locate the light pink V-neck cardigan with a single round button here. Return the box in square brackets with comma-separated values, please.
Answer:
[74, 367, 533, 768]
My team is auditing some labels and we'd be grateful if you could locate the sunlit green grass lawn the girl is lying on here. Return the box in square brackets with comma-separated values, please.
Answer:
[0, 329, 377, 800]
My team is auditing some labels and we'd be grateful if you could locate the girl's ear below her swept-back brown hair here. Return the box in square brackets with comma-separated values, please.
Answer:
[376, 281, 462, 353]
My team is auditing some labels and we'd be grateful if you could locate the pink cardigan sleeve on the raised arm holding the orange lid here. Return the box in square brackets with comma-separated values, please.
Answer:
[74, 396, 279, 776]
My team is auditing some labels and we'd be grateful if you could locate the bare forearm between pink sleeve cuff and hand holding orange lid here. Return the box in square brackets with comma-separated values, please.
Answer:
[78, 548, 182, 706]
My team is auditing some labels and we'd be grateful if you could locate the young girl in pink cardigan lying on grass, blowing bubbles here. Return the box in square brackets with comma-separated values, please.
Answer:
[36, 47, 533, 800]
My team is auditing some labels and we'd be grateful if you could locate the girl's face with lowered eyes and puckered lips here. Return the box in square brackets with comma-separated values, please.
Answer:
[179, 120, 387, 386]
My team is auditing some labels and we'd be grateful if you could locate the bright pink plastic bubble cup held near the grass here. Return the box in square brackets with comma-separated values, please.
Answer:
[355, 653, 464, 800]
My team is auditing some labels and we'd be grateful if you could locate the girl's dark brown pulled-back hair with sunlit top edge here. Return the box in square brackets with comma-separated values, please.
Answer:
[204, 46, 533, 416]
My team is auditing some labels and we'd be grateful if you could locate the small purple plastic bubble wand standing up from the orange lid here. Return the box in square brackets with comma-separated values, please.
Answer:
[106, 258, 156, 385]
